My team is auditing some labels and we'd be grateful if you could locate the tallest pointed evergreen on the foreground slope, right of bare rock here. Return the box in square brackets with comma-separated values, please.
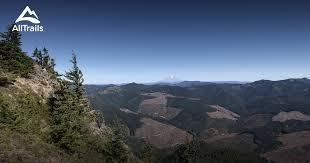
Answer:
[48, 55, 88, 153]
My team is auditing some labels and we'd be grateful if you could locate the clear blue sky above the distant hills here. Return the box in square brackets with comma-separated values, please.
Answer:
[0, 0, 310, 84]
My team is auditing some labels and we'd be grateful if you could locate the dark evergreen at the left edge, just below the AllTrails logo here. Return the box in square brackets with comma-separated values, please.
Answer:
[0, 25, 33, 77]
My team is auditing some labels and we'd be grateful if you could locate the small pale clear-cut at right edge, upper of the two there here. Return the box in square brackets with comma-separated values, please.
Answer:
[272, 111, 310, 122]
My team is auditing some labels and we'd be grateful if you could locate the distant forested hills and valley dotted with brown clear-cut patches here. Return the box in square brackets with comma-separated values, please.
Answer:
[86, 78, 310, 162]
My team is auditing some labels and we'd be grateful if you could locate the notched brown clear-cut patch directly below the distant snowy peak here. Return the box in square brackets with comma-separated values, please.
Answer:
[138, 92, 181, 119]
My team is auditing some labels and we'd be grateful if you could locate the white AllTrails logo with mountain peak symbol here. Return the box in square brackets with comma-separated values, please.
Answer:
[12, 6, 43, 32]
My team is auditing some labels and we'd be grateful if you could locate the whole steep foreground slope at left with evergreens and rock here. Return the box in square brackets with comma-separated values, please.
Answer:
[0, 26, 134, 163]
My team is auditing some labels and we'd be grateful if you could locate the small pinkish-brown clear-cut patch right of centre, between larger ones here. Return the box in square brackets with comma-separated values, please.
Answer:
[207, 105, 240, 121]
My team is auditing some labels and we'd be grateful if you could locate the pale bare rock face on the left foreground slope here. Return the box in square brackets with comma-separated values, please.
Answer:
[14, 65, 59, 99]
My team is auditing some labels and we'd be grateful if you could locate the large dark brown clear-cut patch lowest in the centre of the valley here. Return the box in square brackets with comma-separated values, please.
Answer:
[135, 118, 192, 148]
